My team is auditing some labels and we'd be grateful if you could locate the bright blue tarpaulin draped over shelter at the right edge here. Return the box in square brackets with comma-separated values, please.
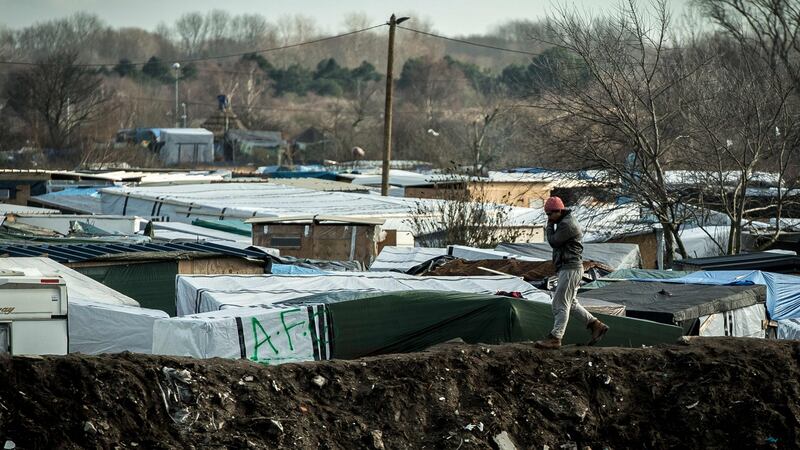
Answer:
[635, 270, 800, 320]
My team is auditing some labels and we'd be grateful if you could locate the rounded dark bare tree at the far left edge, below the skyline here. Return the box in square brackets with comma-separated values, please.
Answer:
[5, 52, 110, 149]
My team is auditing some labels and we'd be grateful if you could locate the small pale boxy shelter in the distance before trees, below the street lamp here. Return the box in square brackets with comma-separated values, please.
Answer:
[156, 128, 214, 166]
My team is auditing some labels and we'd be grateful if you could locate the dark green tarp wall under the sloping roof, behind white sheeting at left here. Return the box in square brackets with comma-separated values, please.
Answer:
[75, 261, 178, 316]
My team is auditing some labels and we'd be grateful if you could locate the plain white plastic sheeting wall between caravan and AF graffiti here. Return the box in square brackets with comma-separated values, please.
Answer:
[67, 298, 169, 355]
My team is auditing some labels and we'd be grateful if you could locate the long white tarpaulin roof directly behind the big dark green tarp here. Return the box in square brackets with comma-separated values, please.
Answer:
[176, 272, 550, 316]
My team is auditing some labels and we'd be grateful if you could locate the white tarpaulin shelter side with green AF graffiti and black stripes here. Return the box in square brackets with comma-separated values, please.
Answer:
[153, 305, 330, 364]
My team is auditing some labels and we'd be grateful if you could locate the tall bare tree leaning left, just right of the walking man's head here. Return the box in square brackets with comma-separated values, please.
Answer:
[534, 0, 695, 264]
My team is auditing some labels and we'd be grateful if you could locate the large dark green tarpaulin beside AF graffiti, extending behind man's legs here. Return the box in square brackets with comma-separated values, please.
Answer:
[328, 291, 682, 359]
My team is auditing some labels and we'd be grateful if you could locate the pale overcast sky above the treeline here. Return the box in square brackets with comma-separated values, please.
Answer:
[0, 0, 688, 35]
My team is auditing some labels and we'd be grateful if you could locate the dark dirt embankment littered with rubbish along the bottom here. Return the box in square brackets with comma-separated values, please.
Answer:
[0, 339, 800, 449]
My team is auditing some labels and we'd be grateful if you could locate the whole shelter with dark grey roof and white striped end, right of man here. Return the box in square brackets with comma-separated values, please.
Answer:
[591, 281, 766, 337]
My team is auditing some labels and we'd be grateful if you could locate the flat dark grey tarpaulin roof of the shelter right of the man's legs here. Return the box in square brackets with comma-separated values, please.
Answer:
[591, 281, 766, 323]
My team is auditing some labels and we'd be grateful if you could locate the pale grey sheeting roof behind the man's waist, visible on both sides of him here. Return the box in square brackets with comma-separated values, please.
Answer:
[495, 243, 642, 270]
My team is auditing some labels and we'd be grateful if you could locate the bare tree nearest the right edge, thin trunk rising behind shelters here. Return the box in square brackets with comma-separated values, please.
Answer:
[675, 34, 800, 254]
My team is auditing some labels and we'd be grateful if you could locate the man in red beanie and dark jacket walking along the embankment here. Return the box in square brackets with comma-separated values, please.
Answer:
[535, 197, 608, 349]
